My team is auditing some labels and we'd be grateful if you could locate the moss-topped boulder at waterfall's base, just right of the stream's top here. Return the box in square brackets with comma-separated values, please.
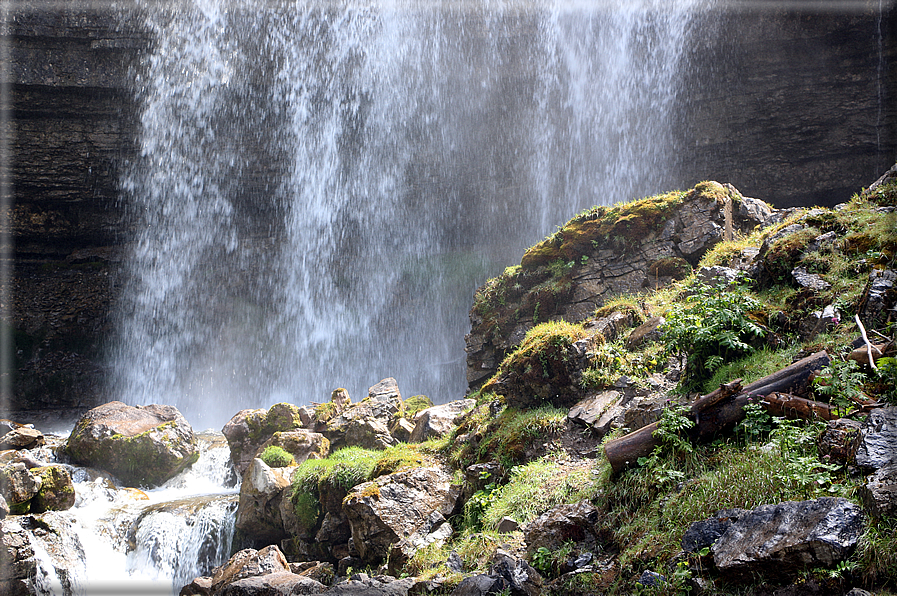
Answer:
[221, 403, 305, 476]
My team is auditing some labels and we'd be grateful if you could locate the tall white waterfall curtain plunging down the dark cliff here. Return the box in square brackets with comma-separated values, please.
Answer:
[112, 0, 707, 427]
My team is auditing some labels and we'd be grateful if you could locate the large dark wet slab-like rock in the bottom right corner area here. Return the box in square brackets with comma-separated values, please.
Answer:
[711, 498, 863, 580]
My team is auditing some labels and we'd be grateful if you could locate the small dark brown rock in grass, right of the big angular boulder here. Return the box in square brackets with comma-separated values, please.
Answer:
[523, 501, 599, 553]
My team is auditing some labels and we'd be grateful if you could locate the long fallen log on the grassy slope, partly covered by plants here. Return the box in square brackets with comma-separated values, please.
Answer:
[604, 350, 830, 474]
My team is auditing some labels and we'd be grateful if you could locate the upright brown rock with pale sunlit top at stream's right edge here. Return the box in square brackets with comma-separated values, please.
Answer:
[236, 458, 296, 542]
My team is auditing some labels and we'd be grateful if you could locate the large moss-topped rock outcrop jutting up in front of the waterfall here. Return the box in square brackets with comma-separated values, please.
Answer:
[466, 182, 769, 389]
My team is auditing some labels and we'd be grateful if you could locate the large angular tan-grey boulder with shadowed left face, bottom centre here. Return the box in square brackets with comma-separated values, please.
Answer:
[343, 467, 459, 563]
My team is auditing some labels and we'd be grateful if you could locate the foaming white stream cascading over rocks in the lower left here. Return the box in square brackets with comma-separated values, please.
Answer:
[16, 431, 239, 596]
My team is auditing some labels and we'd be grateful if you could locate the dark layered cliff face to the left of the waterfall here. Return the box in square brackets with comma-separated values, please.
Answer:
[0, 2, 149, 409]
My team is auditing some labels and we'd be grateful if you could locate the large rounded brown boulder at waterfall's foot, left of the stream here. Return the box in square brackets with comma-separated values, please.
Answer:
[66, 401, 199, 486]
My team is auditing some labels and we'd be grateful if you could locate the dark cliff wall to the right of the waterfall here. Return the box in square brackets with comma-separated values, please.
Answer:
[678, 2, 897, 208]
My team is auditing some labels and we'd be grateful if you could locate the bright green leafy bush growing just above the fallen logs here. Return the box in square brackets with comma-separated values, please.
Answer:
[662, 278, 765, 391]
